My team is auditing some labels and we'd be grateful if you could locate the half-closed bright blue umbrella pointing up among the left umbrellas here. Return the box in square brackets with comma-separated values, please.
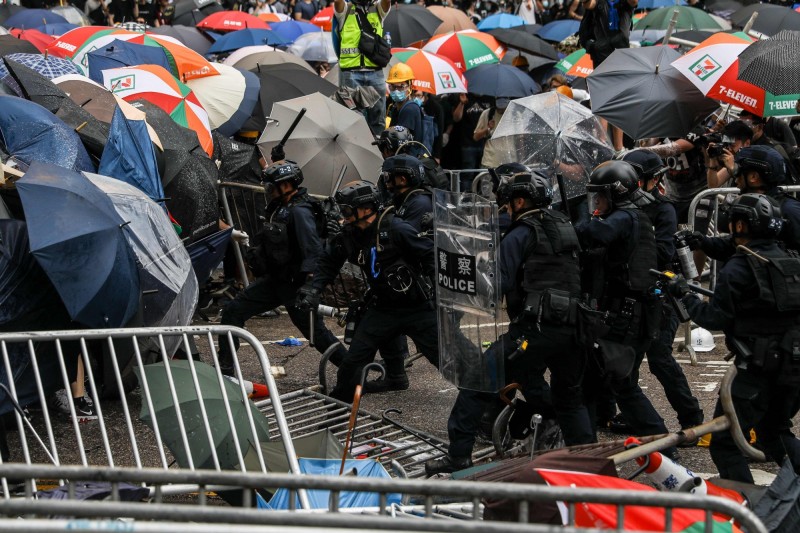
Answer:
[98, 105, 164, 202]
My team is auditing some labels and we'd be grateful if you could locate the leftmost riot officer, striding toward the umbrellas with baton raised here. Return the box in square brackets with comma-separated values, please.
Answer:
[219, 161, 346, 375]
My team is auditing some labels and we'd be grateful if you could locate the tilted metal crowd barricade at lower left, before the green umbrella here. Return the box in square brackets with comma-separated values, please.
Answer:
[0, 326, 308, 507]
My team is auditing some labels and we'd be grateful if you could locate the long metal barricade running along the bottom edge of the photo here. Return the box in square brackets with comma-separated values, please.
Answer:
[0, 464, 767, 533]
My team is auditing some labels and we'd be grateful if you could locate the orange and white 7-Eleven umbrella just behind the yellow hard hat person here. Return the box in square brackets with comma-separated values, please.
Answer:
[392, 48, 467, 94]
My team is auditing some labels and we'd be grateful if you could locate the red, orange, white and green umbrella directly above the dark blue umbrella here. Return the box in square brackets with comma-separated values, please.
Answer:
[422, 30, 506, 71]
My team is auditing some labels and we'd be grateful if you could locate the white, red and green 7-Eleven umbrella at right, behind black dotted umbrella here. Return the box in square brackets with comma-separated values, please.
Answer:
[672, 33, 800, 117]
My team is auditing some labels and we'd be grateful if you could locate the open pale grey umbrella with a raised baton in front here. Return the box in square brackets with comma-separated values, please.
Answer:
[258, 92, 383, 195]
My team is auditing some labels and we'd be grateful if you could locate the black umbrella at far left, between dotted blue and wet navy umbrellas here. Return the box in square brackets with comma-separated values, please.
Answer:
[3, 58, 108, 159]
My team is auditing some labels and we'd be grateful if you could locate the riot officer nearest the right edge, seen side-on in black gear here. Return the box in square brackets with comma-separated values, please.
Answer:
[668, 194, 800, 483]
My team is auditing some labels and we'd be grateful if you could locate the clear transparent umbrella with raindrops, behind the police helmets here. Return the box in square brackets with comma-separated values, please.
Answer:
[488, 92, 614, 198]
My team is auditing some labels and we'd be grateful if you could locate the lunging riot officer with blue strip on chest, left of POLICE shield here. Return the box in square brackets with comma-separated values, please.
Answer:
[298, 181, 439, 401]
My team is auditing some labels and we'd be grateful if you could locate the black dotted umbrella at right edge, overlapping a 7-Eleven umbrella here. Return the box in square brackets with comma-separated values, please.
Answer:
[739, 29, 800, 96]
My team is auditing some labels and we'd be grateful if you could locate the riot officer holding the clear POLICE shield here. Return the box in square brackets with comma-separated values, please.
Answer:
[425, 172, 594, 475]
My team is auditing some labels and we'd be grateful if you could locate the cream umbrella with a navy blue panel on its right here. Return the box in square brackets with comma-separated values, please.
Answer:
[186, 61, 261, 135]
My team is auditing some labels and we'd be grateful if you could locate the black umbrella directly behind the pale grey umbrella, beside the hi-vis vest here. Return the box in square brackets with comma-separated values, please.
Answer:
[251, 63, 338, 115]
